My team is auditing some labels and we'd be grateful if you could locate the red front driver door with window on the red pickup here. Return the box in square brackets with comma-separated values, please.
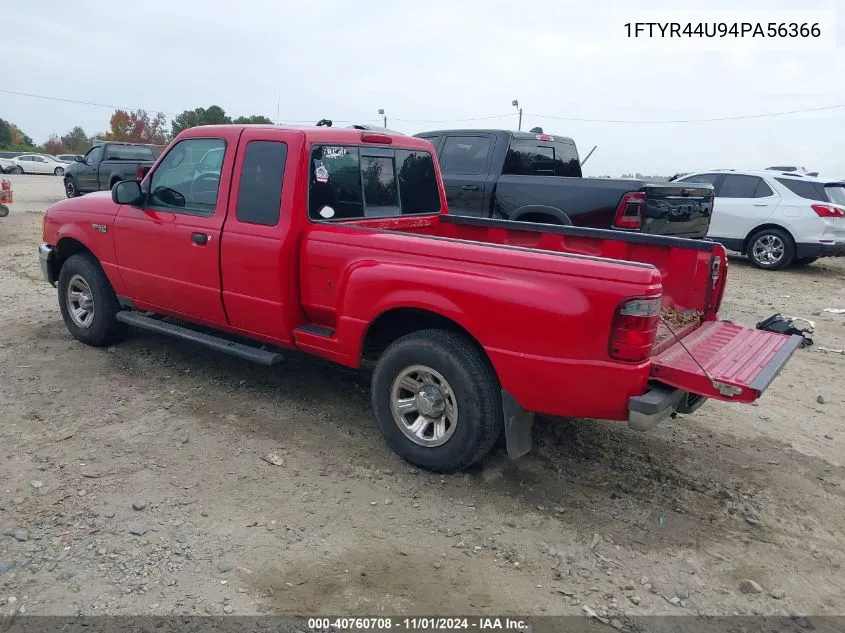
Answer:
[114, 129, 240, 325]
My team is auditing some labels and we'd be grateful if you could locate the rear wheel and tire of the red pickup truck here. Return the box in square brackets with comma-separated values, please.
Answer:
[371, 330, 504, 472]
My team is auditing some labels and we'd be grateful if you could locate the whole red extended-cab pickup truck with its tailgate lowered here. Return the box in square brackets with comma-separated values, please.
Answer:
[39, 125, 802, 471]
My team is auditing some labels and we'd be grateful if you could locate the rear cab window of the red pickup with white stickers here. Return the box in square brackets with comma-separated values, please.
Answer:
[308, 145, 440, 220]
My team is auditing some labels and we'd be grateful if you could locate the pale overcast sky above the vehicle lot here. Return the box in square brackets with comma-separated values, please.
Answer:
[0, 0, 845, 177]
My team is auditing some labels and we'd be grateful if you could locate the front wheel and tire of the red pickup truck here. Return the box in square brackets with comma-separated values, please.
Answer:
[58, 253, 126, 347]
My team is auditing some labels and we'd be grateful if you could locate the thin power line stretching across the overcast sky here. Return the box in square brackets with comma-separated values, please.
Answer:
[0, 88, 845, 125]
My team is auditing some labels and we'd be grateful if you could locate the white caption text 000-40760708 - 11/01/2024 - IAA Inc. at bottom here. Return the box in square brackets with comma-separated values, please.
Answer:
[308, 616, 531, 633]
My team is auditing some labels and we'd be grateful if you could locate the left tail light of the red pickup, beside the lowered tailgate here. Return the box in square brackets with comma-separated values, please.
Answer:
[610, 297, 660, 362]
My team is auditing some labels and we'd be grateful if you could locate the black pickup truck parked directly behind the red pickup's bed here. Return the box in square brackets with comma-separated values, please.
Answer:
[415, 130, 713, 239]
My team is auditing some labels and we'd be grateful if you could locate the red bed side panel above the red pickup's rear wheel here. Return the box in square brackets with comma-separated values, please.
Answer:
[300, 224, 661, 419]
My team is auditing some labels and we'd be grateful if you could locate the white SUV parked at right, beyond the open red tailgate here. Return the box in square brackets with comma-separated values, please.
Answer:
[676, 169, 845, 270]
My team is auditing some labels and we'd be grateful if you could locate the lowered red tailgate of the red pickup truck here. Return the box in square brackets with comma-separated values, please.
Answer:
[651, 321, 803, 403]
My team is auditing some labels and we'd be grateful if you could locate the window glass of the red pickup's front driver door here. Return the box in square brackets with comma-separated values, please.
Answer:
[149, 138, 226, 215]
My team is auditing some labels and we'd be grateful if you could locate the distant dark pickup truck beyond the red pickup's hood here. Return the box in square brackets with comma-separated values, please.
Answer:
[65, 141, 156, 198]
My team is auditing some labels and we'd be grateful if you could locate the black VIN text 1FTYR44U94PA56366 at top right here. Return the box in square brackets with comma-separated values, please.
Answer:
[624, 22, 822, 38]
